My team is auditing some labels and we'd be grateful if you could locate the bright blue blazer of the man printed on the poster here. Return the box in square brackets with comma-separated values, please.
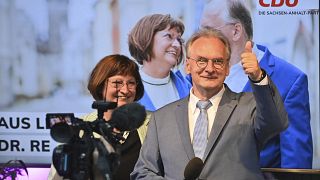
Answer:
[243, 45, 313, 168]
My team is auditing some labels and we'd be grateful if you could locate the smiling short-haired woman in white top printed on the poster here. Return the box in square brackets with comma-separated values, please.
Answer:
[128, 14, 190, 111]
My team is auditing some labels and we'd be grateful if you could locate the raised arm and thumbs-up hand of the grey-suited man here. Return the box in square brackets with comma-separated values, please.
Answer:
[241, 41, 288, 147]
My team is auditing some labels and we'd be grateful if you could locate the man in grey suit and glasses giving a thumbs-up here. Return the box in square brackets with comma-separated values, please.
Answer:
[131, 28, 288, 180]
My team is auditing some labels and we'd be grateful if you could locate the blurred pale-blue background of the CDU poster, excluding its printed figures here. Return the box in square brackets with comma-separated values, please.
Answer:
[0, 0, 320, 179]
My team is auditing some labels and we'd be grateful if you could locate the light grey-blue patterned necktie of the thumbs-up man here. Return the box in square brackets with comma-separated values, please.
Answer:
[193, 100, 212, 159]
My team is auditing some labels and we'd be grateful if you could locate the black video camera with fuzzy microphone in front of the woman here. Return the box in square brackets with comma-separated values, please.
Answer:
[46, 101, 146, 180]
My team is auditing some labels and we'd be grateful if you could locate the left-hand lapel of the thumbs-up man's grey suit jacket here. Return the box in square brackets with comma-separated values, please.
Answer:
[175, 96, 194, 160]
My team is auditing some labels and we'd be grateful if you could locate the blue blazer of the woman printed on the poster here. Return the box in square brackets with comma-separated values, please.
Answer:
[139, 71, 191, 111]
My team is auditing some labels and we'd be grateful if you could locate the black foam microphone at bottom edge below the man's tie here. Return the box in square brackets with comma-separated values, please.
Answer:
[184, 157, 204, 180]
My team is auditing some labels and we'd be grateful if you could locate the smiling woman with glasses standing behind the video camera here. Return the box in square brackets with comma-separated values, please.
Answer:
[48, 54, 147, 180]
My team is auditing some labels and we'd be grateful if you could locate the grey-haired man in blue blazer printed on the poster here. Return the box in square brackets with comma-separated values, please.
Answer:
[201, 0, 313, 168]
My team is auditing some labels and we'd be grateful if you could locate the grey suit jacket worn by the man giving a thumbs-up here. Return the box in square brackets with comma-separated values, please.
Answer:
[131, 81, 288, 180]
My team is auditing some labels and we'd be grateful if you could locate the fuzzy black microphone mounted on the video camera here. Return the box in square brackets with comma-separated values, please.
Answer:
[108, 102, 147, 131]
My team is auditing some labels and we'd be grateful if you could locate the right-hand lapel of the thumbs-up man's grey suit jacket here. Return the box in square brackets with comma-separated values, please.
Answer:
[203, 85, 237, 161]
